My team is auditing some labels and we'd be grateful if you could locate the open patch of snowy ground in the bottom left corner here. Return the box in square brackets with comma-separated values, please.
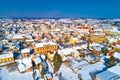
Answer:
[0, 68, 33, 80]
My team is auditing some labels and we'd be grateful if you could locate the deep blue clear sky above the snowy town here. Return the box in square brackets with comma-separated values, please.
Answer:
[0, 0, 120, 18]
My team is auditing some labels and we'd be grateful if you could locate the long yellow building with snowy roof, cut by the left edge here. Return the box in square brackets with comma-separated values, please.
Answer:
[0, 53, 14, 64]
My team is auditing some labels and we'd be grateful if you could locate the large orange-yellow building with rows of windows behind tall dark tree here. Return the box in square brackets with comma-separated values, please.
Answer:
[33, 42, 58, 54]
